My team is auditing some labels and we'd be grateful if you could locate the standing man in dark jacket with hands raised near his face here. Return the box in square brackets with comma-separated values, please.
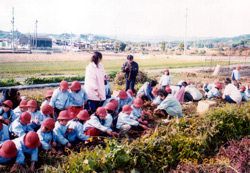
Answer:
[122, 55, 139, 93]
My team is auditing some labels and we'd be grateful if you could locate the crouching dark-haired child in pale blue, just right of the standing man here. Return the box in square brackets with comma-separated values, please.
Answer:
[137, 80, 156, 100]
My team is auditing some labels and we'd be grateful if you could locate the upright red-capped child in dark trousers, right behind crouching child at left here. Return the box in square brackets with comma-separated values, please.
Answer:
[27, 100, 42, 131]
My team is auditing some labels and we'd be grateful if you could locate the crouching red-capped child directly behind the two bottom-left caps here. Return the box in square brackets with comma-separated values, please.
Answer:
[9, 112, 33, 138]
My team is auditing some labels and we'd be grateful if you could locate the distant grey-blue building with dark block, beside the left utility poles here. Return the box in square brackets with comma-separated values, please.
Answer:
[19, 35, 52, 48]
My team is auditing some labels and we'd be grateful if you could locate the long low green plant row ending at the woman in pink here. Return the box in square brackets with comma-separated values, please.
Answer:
[24, 76, 84, 85]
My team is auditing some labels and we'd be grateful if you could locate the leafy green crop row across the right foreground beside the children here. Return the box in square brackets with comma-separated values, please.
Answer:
[45, 103, 250, 172]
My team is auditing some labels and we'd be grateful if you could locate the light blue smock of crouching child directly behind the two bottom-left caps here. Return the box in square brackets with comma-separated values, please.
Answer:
[9, 118, 34, 137]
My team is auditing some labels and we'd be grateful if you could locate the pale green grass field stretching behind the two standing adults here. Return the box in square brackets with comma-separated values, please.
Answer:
[0, 58, 203, 78]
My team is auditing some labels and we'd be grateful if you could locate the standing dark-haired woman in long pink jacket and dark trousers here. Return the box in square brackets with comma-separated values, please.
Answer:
[85, 52, 106, 112]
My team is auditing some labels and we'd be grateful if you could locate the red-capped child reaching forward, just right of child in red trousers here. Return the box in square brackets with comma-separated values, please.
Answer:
[116, 105, 148, 135]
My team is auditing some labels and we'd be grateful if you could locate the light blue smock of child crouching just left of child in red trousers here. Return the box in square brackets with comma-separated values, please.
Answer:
[67, 120, 89, 142]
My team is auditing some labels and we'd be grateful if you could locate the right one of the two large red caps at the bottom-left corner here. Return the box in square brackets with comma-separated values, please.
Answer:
[23, 131, 40, 149]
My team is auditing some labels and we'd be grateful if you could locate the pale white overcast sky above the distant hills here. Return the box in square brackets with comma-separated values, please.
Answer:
[0, 0, 250, 40]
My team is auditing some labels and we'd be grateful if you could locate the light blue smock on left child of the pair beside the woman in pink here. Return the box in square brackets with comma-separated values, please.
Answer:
[49, 88, 70, 110]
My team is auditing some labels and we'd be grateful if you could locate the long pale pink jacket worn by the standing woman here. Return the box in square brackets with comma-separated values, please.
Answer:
[84, 62, 106, 101]
